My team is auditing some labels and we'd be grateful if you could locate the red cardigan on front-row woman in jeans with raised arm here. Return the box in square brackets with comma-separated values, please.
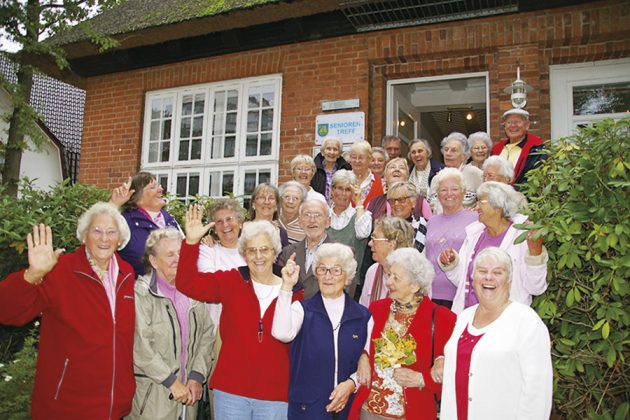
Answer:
[175, 241, 302, 402]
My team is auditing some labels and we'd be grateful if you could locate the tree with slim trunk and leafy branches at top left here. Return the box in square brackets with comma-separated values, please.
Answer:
[0, 0, 118, 197]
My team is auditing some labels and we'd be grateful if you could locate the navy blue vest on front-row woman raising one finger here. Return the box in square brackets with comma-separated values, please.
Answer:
[289, 292, 371, 419]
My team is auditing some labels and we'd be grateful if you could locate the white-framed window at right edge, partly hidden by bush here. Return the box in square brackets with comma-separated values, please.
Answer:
[549, 59, 630, 139]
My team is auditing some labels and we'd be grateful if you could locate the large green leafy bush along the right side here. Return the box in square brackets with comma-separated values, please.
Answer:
[525, 119, 630, 420]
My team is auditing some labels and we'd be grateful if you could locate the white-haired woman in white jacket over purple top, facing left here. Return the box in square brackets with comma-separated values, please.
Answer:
[438, 181, 548, 314]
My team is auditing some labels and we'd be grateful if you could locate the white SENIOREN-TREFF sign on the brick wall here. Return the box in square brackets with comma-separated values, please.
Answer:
[315, 112, 365, 144]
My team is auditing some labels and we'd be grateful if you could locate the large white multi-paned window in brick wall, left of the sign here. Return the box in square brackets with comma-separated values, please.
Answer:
[142, 75, 282, 201]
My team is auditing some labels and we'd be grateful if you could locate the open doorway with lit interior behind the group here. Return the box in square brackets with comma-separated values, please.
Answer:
[387, 72, 489, 160]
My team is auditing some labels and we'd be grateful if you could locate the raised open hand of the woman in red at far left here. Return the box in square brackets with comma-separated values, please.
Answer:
[24, 223, 64, 284]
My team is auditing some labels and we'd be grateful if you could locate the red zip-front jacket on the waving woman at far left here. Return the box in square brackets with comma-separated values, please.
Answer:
[0, 247, 136, 419]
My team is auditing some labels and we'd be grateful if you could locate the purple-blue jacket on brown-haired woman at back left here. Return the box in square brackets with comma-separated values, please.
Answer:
[119, 209, 179, 276]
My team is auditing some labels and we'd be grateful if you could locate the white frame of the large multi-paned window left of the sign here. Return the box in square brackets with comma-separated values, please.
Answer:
[141, 74, 282, 201]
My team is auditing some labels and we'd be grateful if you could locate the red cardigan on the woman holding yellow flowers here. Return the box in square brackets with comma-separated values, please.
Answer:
[348, 297, 456, 420]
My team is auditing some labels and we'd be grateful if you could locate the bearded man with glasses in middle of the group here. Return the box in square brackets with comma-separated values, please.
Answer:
[278, 199, 331, 299]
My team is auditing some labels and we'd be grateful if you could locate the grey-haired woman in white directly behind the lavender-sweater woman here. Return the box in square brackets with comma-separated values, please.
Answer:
[428, 132, 483, 214]
